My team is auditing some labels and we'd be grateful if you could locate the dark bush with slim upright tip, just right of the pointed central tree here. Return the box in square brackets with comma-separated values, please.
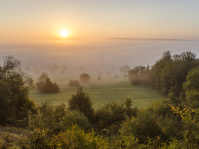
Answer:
[95, 98, 137, 135]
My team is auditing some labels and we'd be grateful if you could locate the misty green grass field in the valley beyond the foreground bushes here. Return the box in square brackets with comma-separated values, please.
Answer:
[30, 81, 166, 109]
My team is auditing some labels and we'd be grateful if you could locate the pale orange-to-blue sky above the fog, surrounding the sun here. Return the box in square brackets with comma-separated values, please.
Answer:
[0, 0, 199, 41]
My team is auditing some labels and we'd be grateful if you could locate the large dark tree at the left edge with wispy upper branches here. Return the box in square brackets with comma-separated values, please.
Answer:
[0, 56, 36, 126]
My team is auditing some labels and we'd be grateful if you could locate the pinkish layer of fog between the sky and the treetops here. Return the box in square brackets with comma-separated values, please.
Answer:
[0, 39, 199, 84]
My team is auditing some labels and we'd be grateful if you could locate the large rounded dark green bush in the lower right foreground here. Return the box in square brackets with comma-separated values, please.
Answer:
[120, 102, 182, 144]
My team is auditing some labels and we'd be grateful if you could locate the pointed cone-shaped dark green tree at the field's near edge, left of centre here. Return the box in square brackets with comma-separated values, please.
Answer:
[68, 87, 94, 120]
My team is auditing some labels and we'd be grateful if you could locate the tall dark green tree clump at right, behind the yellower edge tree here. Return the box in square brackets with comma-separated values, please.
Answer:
[150, 51, 199, 99]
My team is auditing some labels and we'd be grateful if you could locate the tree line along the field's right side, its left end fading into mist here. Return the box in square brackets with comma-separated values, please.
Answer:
[128, 51, 199, 106]
